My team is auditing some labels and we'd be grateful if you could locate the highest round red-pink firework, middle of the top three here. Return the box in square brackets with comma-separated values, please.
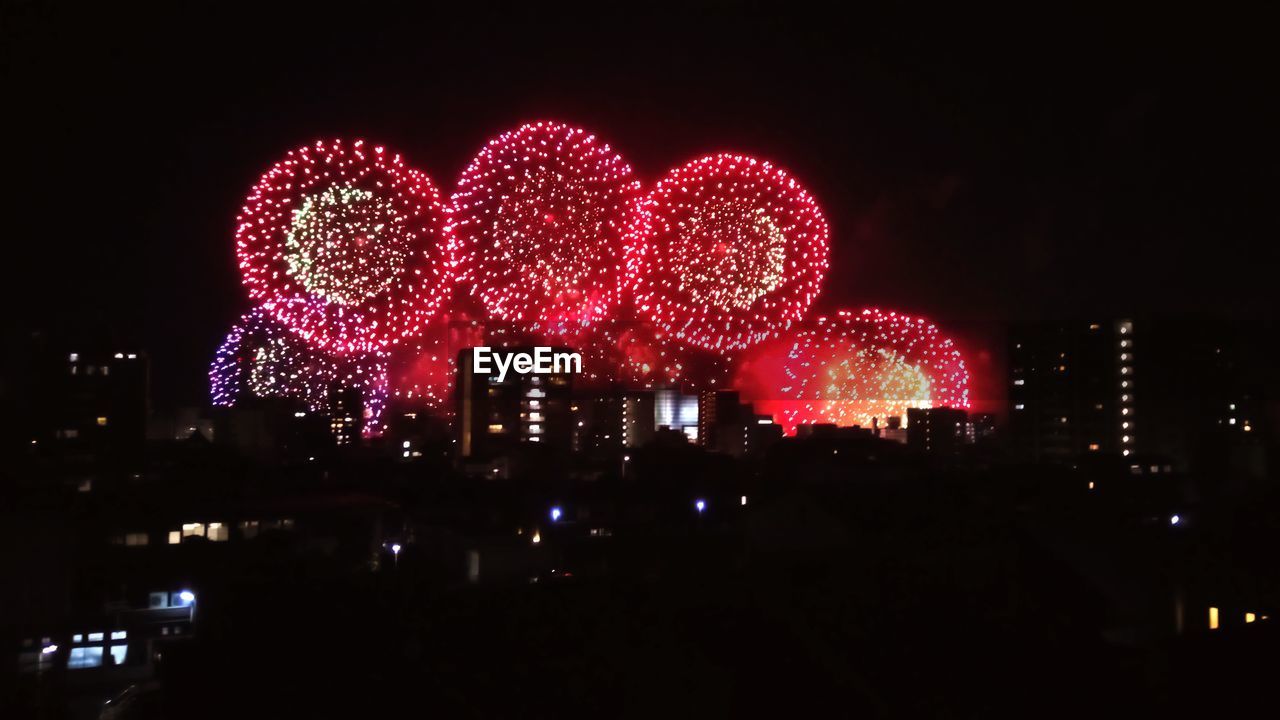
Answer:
[448, 122, 641, 340]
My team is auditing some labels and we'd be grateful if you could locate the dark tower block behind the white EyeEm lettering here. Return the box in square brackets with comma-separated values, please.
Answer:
[454, 347, 575, 460]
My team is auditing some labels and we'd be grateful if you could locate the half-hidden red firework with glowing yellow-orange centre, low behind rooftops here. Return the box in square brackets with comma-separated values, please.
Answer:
[735, 309, 969, 434]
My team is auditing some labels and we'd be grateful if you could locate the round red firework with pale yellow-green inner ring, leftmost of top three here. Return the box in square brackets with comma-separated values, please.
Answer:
[236, 141, 452, 355]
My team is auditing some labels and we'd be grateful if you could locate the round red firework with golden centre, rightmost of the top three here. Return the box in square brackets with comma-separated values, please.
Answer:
[627, 155, 828, 352]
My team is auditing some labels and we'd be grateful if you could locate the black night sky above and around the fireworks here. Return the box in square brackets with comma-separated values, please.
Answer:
[0, 1, 1280, 405]
